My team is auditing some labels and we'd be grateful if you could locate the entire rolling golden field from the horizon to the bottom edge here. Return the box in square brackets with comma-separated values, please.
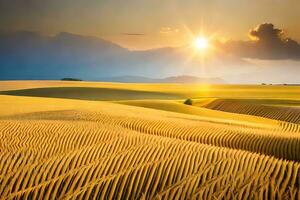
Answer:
[0, 81, 300, 199]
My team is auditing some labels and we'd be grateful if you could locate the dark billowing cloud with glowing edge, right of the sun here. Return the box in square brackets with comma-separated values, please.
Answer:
[222, 23, 300, 60]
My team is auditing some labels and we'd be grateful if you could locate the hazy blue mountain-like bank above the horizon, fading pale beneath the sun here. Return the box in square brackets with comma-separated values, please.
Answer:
[0, 31, 298, 83]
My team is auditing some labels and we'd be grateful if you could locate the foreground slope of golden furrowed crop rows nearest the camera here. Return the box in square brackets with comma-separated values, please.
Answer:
[0, 119, 300, 199]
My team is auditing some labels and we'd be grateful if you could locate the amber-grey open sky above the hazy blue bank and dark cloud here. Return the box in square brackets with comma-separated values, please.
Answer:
[0, 0, 300, 50]
